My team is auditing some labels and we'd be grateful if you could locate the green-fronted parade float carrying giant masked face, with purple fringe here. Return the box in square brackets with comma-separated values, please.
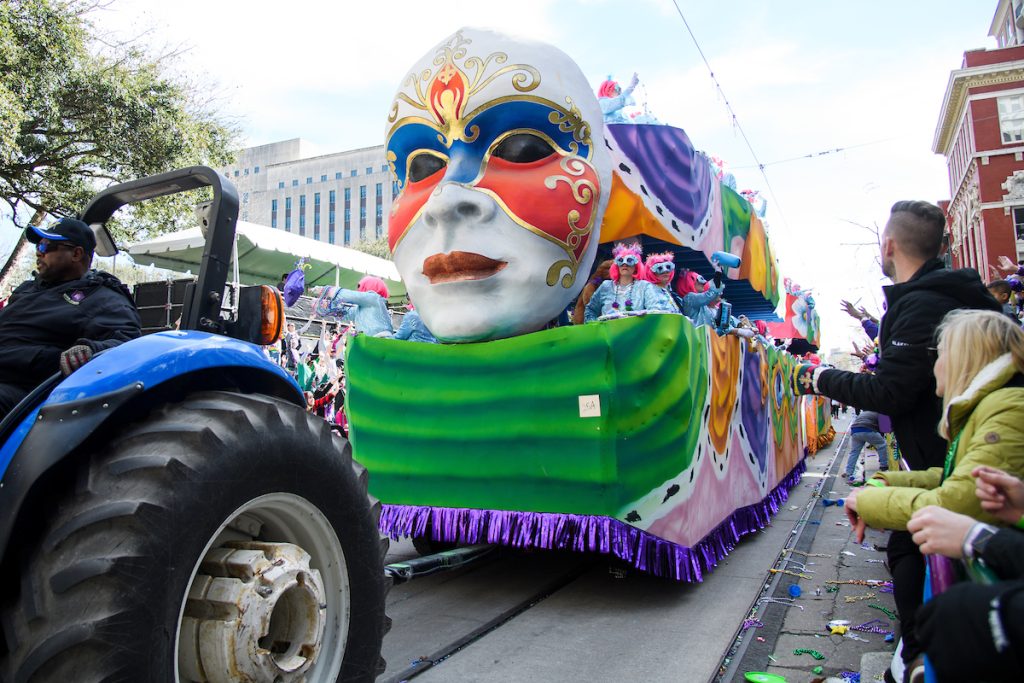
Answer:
[346, 29, 829, 581]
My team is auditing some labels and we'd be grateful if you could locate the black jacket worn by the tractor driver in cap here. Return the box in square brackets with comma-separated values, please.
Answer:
[0, 270, 141, 389]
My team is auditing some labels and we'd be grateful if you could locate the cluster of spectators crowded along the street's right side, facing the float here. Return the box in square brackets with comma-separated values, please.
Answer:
[795, 202, 1024, 683]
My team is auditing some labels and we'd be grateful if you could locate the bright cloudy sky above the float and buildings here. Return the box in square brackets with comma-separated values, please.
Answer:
[75, 0, 996, 349]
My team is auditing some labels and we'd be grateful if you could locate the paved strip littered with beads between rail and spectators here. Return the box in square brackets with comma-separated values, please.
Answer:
[732, 412, 897, 683]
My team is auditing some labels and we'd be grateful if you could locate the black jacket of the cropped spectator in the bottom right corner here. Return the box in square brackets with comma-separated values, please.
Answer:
[918, 528, 1024, 683]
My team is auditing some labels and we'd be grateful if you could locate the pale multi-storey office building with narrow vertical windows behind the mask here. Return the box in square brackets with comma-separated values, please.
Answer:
[221, 138, 398, 247]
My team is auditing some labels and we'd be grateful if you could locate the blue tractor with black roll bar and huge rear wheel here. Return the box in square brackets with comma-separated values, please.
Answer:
[0, 166, 387, 683]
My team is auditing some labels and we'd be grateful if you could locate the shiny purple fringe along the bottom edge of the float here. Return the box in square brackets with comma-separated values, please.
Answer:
[380, 460, 807, 582]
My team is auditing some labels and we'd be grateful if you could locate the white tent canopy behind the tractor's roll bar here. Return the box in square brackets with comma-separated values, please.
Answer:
[126, 220, 406, 298]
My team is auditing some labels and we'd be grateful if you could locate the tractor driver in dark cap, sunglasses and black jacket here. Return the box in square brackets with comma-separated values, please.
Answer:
[0, 218, 141, 418]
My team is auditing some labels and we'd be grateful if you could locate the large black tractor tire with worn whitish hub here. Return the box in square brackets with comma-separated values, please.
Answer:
[0, 391, 387, 683]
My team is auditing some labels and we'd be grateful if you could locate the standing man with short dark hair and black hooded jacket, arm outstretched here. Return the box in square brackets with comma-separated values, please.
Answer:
[797, 202, 999, 679]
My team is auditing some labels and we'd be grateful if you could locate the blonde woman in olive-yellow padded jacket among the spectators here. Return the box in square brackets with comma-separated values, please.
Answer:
[845, 310, 1024, 680]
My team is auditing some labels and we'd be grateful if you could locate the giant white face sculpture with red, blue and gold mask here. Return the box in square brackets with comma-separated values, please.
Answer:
[386, 29, 611, 342]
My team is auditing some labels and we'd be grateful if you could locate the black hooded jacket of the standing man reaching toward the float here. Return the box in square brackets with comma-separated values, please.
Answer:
[818, 258, 1000, 470]
